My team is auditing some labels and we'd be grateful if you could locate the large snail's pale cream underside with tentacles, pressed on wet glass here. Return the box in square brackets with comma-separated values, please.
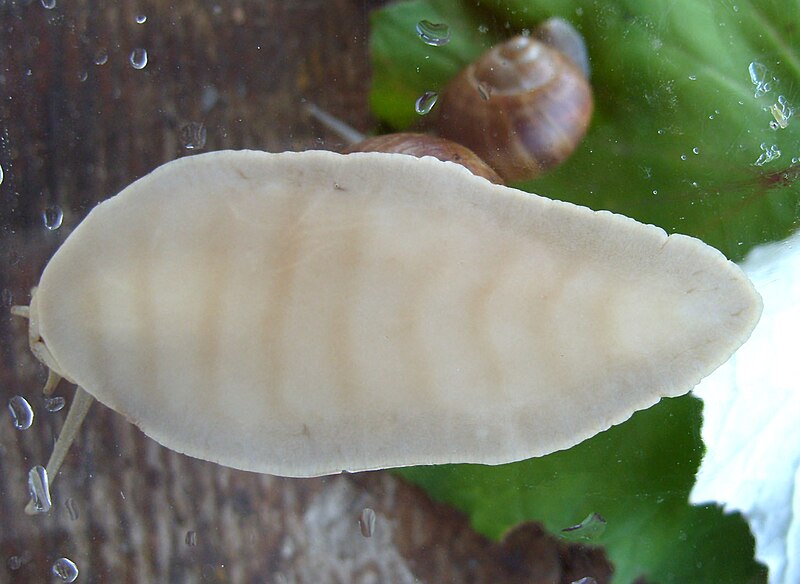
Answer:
[12, 150, 761, 502]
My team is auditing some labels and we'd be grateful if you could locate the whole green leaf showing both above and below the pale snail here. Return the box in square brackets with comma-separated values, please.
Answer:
[371, 0, 800, 583]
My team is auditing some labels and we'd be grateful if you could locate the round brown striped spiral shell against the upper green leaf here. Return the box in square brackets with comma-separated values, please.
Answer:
[436, 36, 594, 182]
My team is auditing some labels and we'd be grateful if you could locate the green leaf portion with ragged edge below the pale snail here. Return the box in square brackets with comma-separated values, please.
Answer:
[397, 396, 765, 584]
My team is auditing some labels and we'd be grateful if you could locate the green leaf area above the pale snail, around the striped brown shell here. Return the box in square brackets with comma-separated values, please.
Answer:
[371, 0, 800, 259]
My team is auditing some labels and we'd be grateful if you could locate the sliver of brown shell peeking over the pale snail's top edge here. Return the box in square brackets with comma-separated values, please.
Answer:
[347, 132, 505, 185]
